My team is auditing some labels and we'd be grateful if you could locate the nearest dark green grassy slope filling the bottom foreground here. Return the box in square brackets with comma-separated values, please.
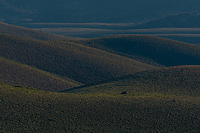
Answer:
[0, 84, 200, 133]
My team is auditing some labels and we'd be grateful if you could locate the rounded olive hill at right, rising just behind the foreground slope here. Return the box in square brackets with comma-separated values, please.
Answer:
[64, 66, 200, 97]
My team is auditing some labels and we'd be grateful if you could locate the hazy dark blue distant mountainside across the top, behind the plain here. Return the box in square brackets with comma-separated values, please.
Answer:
[0, 0, 200, 23]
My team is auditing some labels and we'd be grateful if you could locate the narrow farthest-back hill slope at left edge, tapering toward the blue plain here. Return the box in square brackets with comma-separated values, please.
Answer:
[0, 22, 75, 40]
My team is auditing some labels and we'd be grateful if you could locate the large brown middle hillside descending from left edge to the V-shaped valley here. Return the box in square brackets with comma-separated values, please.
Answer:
[0, 34, 157, 84]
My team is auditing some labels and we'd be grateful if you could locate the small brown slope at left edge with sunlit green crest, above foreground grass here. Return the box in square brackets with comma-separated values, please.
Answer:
[0, 58, 81, 91]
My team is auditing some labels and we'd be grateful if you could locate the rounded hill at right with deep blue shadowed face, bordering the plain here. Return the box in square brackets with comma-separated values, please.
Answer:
[76, 35, 200, 66]
